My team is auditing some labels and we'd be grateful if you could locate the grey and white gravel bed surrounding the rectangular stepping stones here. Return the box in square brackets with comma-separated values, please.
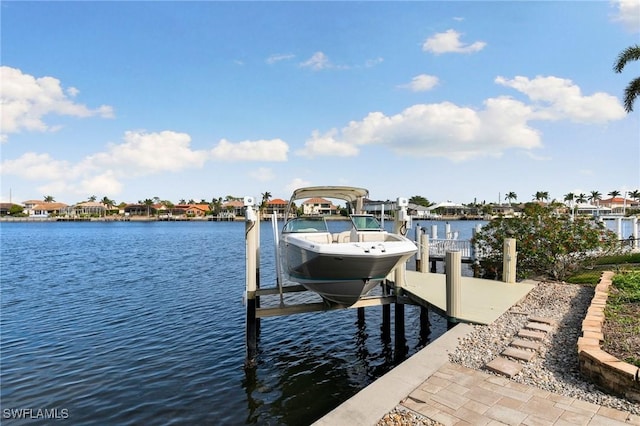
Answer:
[378, 282, 640, 426]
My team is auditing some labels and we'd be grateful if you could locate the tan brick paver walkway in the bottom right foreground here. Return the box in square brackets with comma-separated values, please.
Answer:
[402, 363, 640, 426]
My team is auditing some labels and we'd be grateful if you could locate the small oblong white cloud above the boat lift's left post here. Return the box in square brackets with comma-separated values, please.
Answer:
[211, 139, 289, 161]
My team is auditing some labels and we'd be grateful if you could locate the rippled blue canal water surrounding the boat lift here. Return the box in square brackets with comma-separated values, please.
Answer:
[0, 221, 474, 425]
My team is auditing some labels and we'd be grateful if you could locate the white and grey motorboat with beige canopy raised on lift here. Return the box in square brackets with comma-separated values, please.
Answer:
[277, 186, 417, 306]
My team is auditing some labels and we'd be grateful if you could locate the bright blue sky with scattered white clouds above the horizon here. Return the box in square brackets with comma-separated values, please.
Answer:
[0, 0, 640, 204]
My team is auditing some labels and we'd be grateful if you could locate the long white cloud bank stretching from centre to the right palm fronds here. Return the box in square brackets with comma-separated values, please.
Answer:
[298, 76, 625, 161]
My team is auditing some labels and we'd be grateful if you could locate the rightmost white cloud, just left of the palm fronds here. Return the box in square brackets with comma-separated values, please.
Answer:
[495, 76, 626, 123]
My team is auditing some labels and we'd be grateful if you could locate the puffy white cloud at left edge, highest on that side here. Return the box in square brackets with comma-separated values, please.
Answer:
[0, 66, 113, 141]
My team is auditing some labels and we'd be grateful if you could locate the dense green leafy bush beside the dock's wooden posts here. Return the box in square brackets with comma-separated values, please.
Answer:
[472, 203, 618, 280]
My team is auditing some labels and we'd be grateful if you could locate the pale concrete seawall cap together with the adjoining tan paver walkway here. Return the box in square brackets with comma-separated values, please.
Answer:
[314, 324, 640, 426]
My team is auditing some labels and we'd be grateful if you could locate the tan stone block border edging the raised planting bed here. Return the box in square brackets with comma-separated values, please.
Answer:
[578, 271, 640, 402]
